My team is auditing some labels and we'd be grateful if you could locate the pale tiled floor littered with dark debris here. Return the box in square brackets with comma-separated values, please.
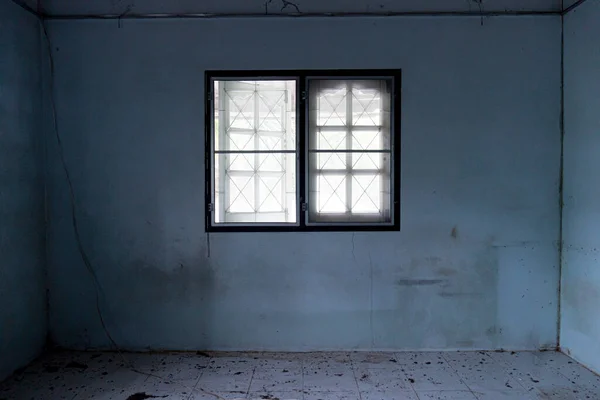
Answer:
[0, 352, 600, 400]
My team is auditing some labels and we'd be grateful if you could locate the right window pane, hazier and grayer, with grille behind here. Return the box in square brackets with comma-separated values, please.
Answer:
[307, 79, 392, 224]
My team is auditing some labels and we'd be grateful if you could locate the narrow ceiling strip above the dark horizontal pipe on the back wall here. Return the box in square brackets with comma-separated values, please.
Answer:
[22, 0, 577, 16]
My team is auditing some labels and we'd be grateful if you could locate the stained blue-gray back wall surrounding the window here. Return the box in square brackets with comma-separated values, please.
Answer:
[49, 17, 560, 350]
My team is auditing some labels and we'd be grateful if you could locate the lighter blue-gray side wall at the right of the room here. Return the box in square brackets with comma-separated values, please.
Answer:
[561, 0, 600, 372]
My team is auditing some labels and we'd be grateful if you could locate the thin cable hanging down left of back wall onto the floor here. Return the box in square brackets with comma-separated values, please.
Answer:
[40, 19, 225, 400]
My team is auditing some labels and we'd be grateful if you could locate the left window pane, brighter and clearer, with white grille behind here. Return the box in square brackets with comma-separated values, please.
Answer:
[212, 80, 298, 224]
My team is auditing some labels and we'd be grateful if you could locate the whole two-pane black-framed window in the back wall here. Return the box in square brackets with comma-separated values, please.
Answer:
[206, 70, 400, 231]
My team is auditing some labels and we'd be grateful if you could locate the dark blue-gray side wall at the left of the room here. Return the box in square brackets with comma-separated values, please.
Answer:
[0, 0, 47, 380]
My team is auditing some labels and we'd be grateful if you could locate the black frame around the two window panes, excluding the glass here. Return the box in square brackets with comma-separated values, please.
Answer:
[204, 69, 402, 232]
